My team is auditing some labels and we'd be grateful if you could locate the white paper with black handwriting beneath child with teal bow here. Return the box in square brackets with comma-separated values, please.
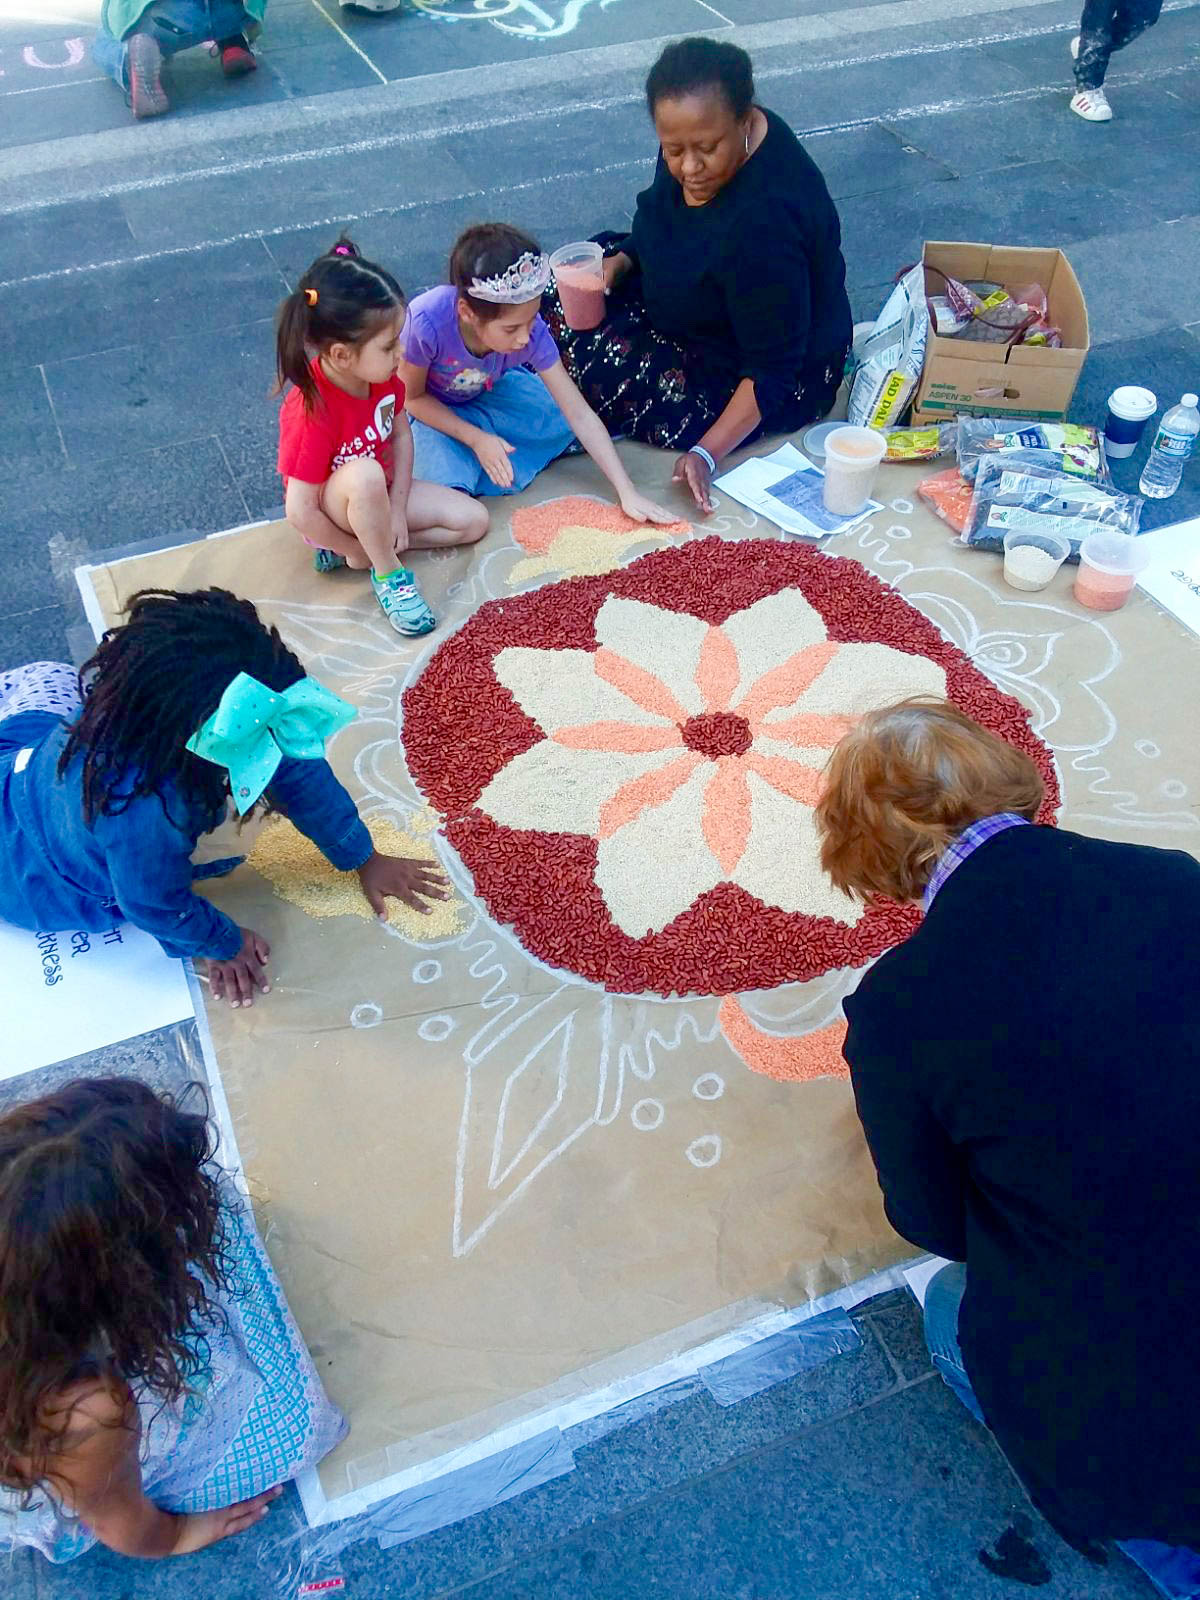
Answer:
[0, 922, 194, 1078]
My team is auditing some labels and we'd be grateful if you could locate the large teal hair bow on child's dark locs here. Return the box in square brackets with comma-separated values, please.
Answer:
[187, 672, 358, 814]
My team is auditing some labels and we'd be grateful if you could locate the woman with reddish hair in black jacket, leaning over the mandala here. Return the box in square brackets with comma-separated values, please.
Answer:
[816, 701, 1200, 1600]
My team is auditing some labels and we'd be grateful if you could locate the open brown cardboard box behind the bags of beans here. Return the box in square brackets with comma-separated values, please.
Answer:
[912, 242, 1091, 422]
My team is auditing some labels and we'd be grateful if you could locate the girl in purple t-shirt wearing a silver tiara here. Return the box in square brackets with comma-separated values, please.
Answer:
[400, 222, 677, 522]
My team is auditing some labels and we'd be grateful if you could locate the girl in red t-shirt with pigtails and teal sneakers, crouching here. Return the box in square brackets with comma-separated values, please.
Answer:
[275, 235, 488, 635]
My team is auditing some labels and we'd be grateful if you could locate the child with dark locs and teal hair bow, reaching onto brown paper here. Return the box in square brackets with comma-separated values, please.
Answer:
[0, 589, 446, 1006]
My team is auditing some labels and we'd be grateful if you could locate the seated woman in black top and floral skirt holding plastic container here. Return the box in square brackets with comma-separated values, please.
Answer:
[547, 38, 851, 510]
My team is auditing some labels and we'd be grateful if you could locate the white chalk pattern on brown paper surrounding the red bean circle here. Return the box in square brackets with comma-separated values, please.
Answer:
[251, 492, 1200, 1258]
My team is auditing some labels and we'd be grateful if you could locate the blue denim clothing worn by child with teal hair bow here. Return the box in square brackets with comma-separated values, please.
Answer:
[0, 712, 373, 962]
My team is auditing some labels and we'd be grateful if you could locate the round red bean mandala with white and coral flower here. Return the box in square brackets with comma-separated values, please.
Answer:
[403, 538, 1058, 995]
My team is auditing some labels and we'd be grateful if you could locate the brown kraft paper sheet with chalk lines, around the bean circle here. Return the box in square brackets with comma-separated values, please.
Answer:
[91, 446, 1200, 1499]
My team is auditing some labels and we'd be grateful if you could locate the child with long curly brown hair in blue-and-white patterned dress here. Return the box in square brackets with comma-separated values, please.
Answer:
[0, 1078, 346, 1562]
